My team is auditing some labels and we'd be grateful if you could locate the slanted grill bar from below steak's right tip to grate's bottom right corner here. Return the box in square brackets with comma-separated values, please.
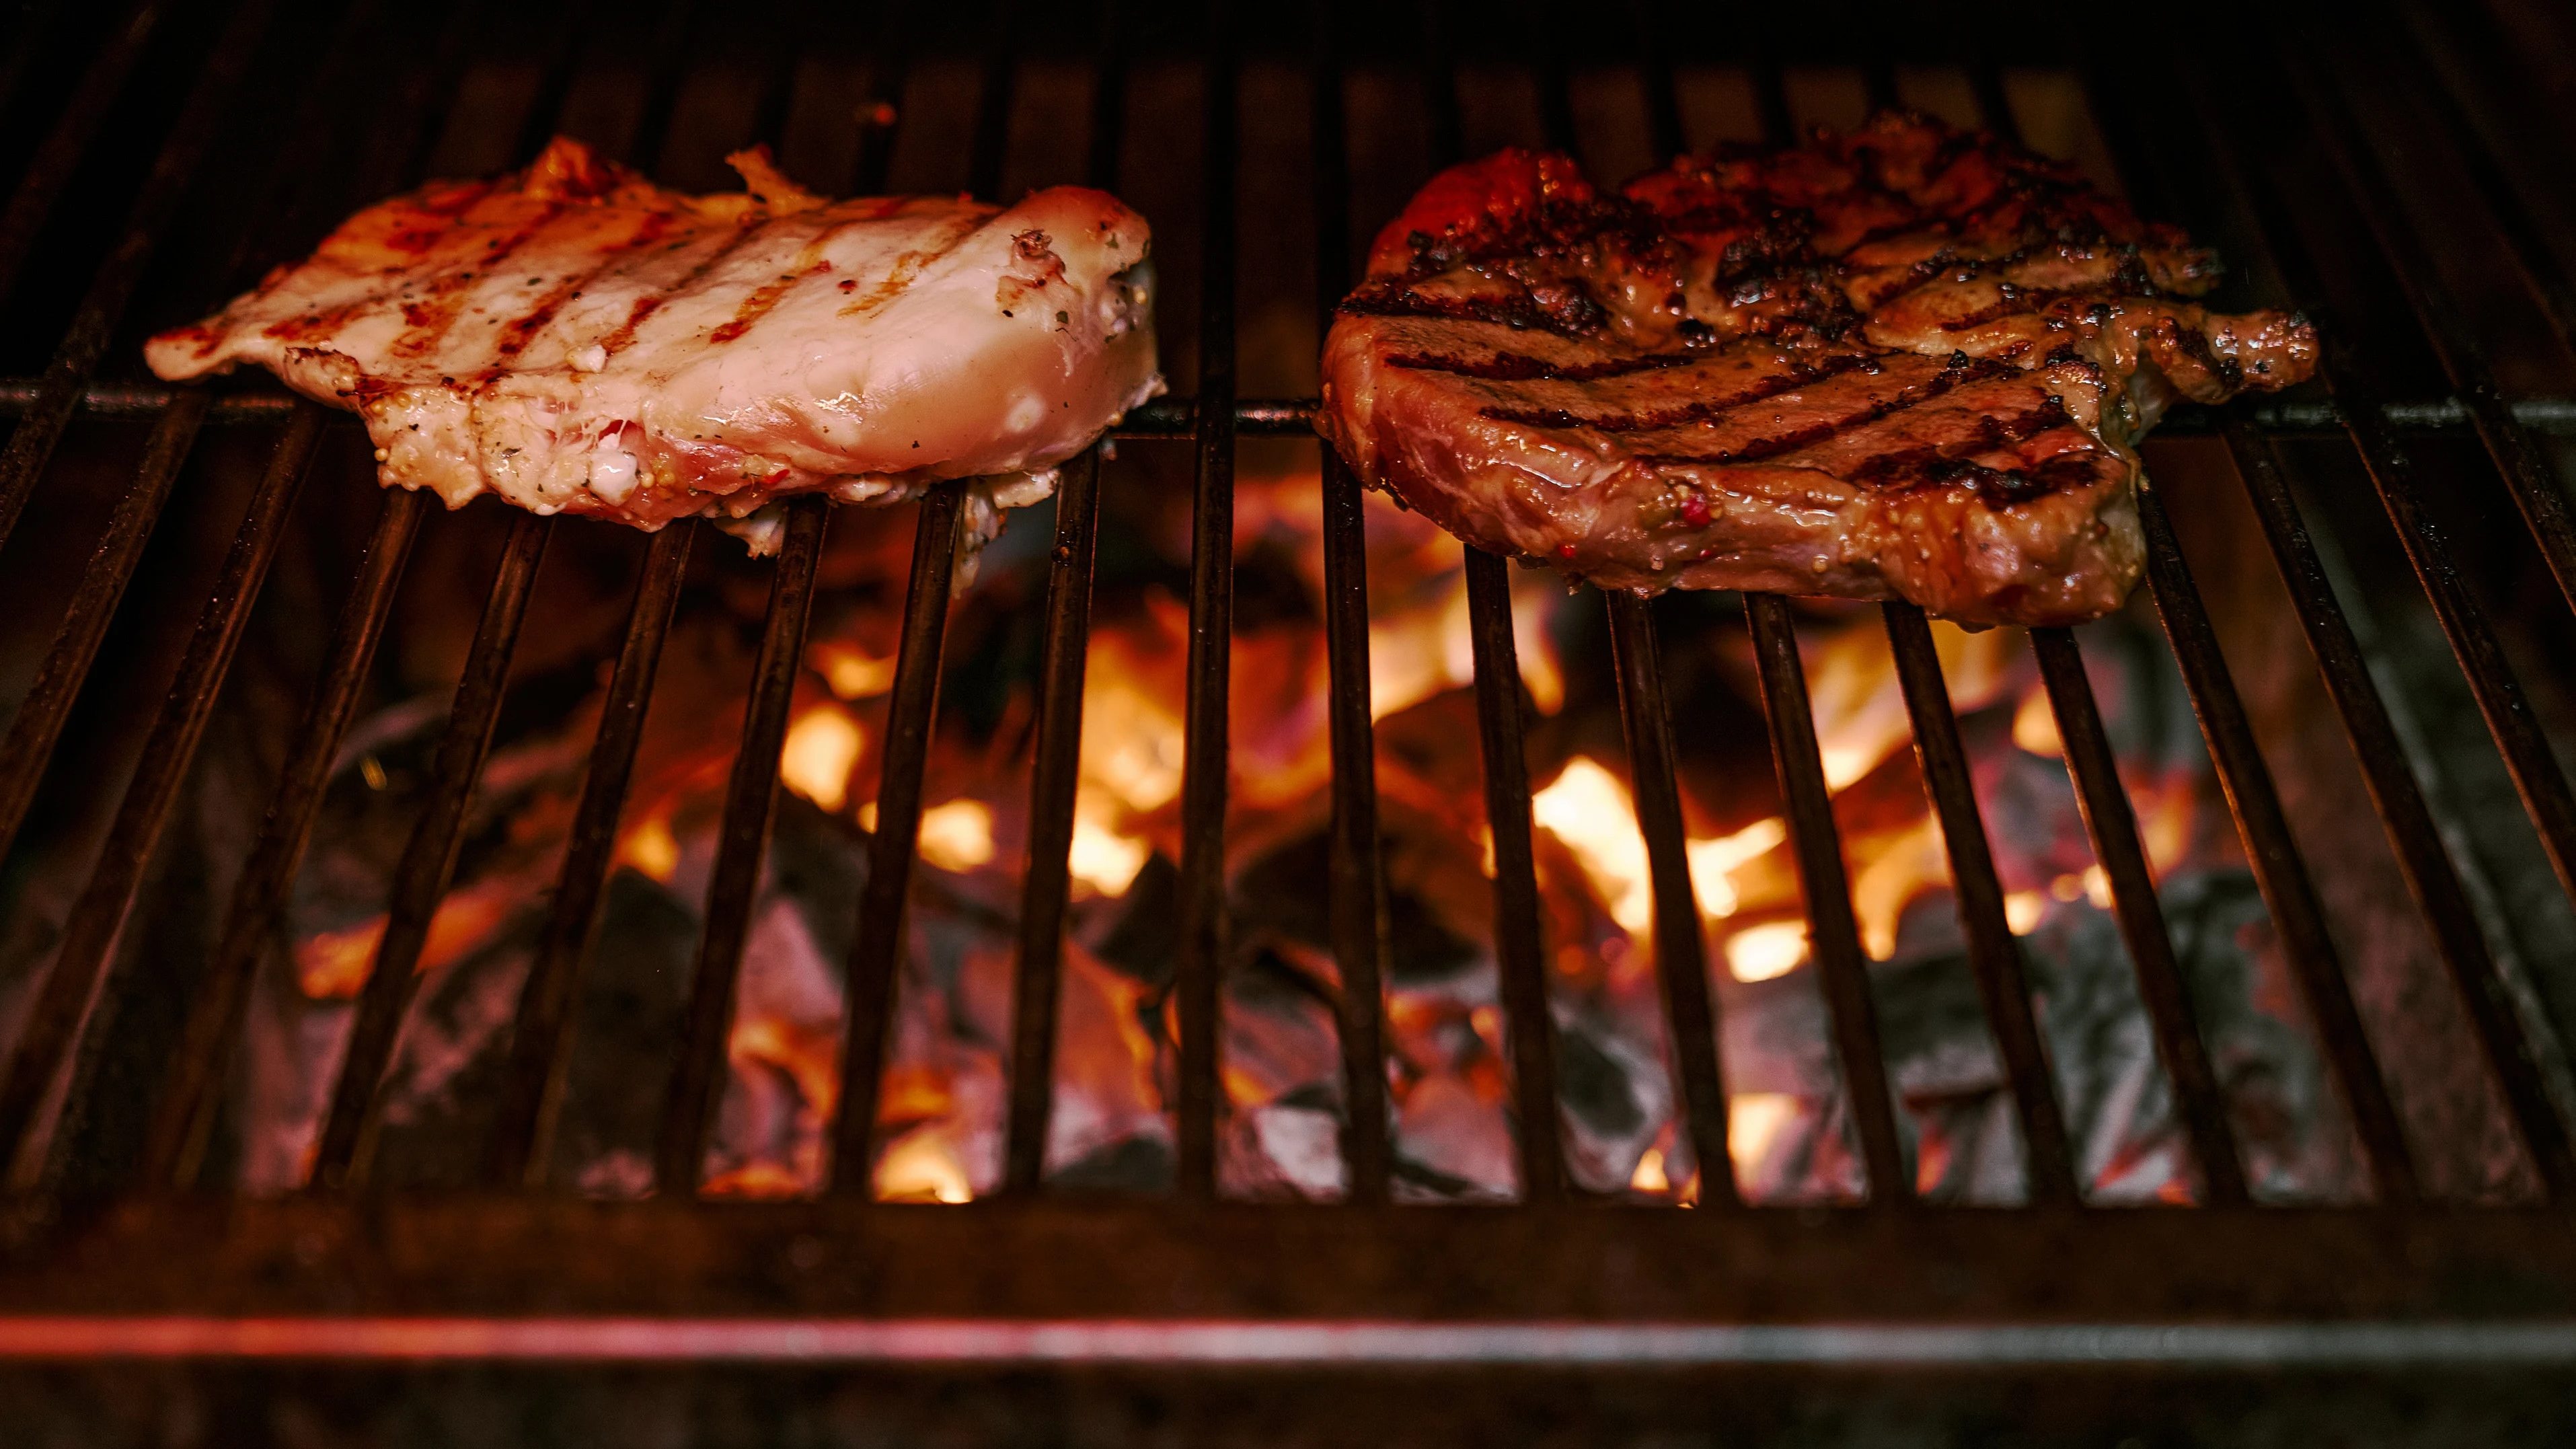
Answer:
[2228, 428, 2576, 1199]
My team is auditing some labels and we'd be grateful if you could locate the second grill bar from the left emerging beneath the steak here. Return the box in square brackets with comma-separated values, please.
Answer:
[1466, 547, 1566, 1201]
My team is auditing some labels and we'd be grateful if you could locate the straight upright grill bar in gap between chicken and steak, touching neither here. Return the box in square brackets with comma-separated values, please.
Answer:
[1172, 39, 1236, 1196]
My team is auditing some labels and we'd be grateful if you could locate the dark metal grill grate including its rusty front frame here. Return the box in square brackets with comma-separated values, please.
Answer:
[0, 0, 2576, 1359]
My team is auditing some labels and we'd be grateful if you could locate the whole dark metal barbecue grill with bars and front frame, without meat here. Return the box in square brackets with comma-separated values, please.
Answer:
[0, 0, 2576, 1444]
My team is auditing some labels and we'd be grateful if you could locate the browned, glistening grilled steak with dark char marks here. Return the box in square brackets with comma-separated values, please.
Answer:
[1319, 114, 2316, 624]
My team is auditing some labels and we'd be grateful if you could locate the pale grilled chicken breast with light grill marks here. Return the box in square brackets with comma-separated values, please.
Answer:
[147, 139, 1162, 549]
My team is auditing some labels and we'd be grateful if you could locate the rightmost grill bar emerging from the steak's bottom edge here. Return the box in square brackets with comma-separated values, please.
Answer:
[2030, 626, 2246, 1207]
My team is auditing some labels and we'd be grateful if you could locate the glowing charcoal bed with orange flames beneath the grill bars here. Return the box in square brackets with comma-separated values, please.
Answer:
[227, 433, 2313, 1204]
